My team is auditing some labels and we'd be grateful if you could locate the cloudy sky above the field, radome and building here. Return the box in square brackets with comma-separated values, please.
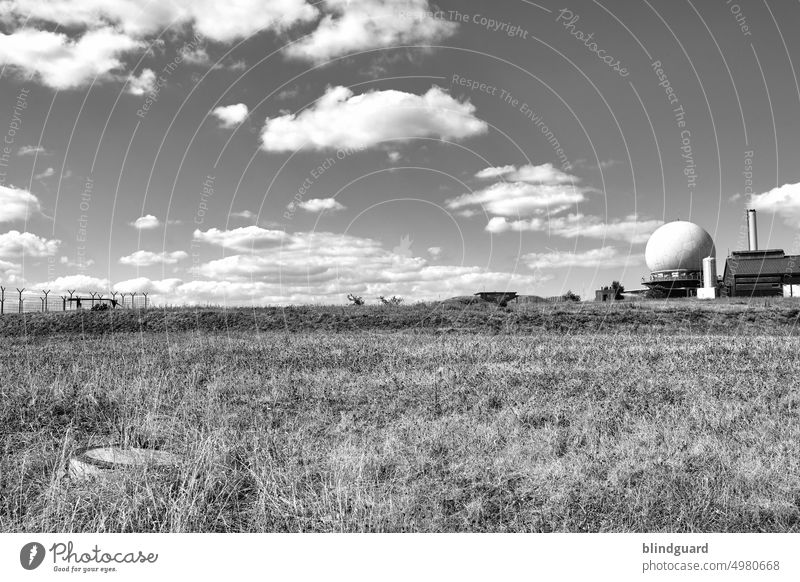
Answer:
[0, 0, 800, 305]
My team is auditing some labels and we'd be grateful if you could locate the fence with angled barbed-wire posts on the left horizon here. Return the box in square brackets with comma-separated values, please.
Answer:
[0, 287, 149, 315]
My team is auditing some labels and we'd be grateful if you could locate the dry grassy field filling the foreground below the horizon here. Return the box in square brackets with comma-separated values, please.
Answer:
[0, 302, 800, 532]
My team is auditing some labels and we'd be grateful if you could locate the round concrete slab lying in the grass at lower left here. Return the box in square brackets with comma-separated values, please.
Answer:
[69, 446, 178, 479]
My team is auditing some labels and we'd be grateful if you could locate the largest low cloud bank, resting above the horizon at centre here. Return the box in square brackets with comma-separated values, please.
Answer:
[176, 227, 543, 303]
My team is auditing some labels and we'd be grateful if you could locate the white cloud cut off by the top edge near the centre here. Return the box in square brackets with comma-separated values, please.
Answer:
[286, 0, 458, 62]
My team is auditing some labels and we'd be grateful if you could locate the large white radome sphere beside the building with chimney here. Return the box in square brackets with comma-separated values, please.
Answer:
[644, 220, 717, 272]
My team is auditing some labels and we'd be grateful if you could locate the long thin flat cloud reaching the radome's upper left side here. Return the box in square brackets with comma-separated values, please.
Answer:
[486, 214, 664, 244]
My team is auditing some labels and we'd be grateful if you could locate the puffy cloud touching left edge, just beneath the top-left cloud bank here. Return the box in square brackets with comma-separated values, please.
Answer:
[0, 28, 143, 90]
